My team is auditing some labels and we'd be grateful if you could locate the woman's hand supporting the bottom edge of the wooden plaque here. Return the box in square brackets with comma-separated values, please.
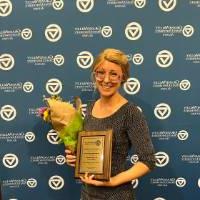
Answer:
[80, 173, 116, 187]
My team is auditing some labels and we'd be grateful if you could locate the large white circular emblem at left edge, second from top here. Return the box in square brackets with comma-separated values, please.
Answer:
[0, 53, 15, 71]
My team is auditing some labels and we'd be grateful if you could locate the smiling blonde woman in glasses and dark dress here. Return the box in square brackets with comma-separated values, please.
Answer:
[66, 49, 155, 200]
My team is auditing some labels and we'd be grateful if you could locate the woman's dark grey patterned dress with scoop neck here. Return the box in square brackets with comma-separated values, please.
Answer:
[81, 102, 155, 200]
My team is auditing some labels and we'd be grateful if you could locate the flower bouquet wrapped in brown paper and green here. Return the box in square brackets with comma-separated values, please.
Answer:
[38, 96, 83, 152]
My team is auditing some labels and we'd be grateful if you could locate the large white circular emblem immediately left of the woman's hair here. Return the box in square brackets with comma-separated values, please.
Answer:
[76, 51, 94, 69]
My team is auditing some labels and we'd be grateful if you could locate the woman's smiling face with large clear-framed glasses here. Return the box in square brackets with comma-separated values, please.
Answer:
[94, 60, 123, 97]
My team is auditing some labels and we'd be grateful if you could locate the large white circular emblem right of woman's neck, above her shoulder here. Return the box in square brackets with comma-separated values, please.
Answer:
[124, 78, 140, 94]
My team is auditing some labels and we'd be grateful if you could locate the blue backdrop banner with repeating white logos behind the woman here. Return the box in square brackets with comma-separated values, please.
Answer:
[0, 0, 200, 200]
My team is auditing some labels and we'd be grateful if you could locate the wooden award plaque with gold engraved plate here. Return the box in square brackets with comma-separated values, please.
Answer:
[75, 130, 112, 181]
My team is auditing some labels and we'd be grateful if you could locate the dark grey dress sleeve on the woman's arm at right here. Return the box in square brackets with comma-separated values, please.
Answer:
[126, 104, 156, 170]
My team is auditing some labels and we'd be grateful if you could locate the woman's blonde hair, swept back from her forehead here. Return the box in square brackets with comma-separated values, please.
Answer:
[92, 48, 130, 83]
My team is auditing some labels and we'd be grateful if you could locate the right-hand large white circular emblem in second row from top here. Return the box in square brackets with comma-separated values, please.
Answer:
[125, 22, 142, 40]
